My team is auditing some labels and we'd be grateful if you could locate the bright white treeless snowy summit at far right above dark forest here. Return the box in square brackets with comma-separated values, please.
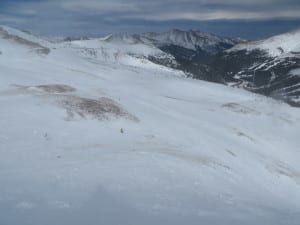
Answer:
[228, 29, 300, 57]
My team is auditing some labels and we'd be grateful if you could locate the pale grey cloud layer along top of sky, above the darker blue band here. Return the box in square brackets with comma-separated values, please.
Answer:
[54, 0, 300, 21]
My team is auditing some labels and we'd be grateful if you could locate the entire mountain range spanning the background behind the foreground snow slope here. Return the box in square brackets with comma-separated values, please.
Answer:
[0, 26, 300, 106]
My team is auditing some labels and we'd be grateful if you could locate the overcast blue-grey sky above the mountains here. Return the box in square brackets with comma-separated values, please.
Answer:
[0, 0, 300, 39]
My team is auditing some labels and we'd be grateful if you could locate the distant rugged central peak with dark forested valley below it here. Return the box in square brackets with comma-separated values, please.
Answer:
[106, 29, 242, 81]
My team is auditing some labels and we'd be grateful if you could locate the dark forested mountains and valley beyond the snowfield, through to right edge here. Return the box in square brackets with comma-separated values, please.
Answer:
[107, 27, 300, 106]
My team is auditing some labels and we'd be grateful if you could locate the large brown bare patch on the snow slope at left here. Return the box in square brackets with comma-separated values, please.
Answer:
[6, 84, 139, 122]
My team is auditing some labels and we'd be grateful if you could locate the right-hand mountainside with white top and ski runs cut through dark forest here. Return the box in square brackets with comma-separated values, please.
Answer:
[210, 30, 300, 106]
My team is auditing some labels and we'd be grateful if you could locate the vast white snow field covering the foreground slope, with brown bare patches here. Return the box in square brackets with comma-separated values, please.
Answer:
[0, 27, 300, 225]
